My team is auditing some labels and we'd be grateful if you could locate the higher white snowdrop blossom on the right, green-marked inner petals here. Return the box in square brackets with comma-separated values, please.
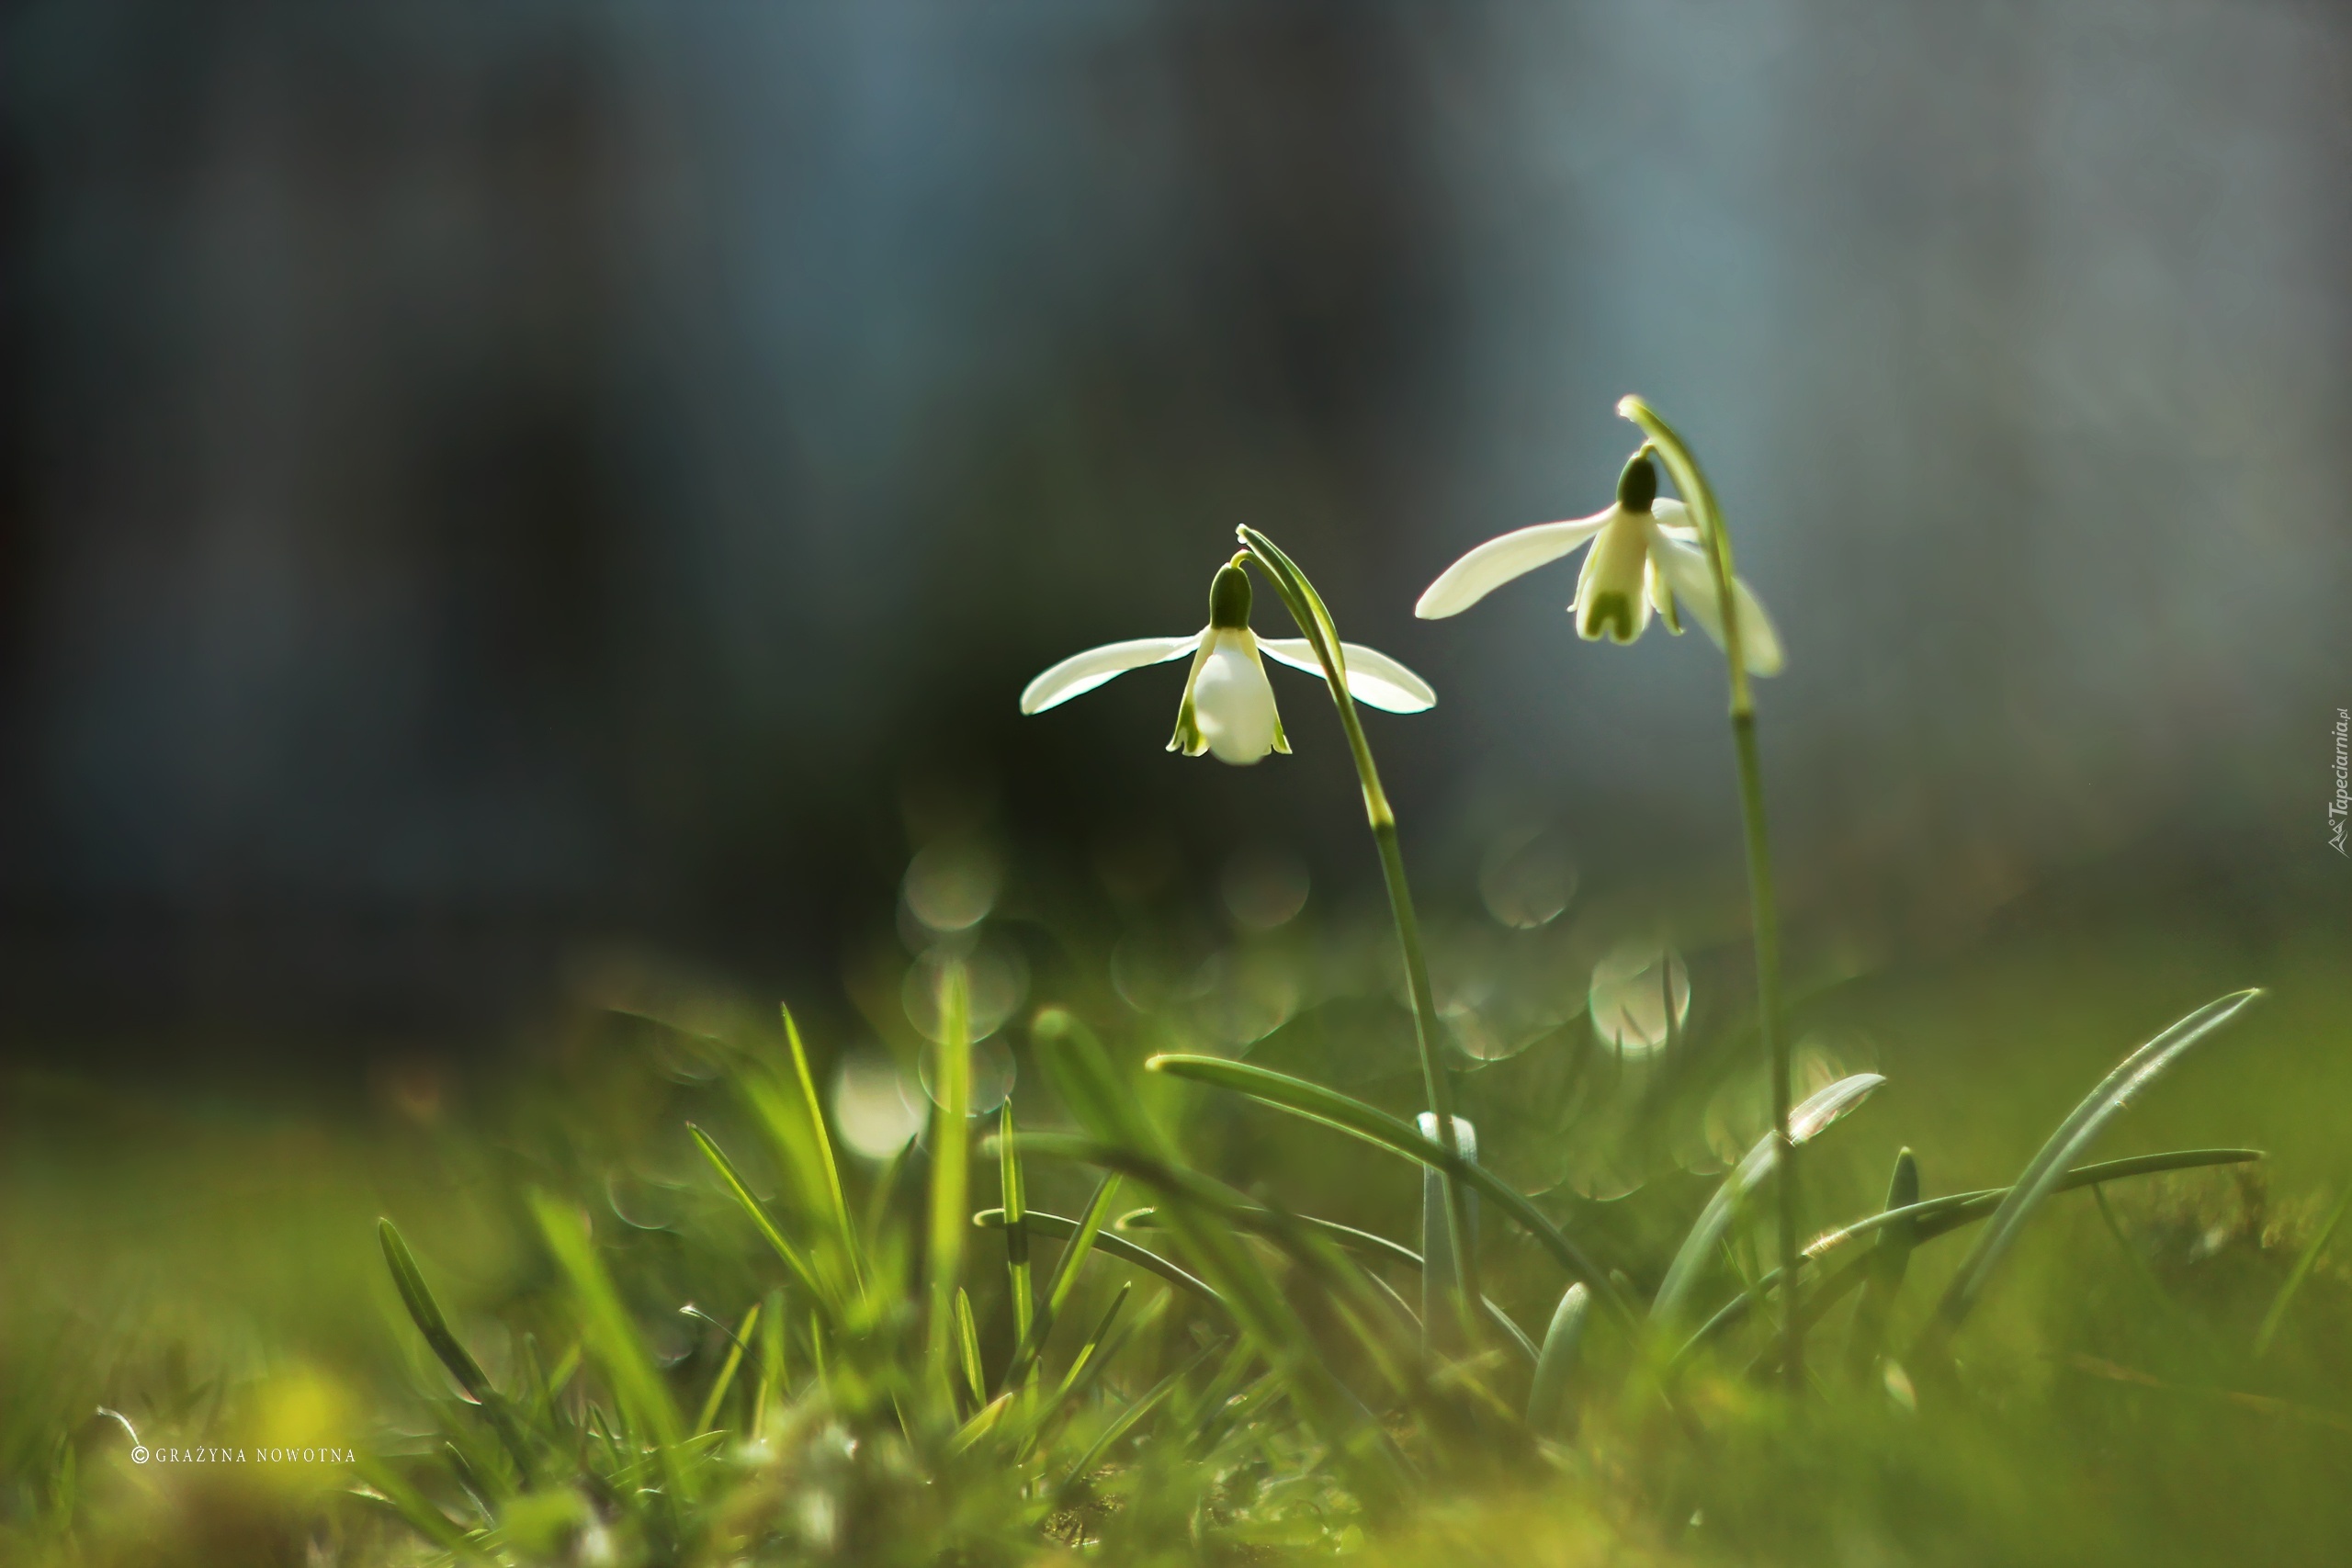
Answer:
[1414, 446, 1781, 674]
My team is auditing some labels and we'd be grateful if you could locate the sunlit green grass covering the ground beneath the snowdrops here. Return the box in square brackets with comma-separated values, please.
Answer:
[0, 884, 2352, 1565]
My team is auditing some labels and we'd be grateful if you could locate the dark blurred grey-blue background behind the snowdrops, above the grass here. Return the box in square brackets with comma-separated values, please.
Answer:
[0, 0, 2352, 1081]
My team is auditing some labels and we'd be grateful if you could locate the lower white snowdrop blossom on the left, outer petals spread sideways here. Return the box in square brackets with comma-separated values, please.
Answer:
[1021, 558, 1437, 766]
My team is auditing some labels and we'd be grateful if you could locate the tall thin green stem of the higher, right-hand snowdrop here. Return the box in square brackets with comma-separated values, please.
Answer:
[1618, 398, 1804, 1394]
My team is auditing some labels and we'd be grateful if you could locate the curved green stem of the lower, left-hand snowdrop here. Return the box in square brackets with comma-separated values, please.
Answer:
[1235, 526, 1479, 1349]
